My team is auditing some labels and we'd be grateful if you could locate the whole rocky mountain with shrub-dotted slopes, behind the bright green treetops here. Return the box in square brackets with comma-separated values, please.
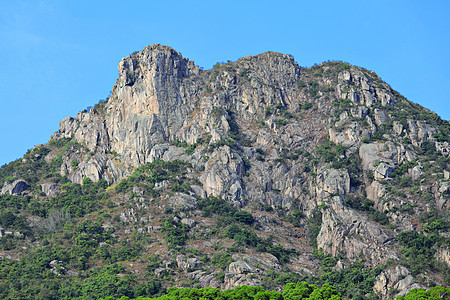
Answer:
[0, 44, 450, 299]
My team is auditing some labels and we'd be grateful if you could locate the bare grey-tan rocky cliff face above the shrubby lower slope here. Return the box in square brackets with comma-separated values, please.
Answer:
[1, 45, 450, 297]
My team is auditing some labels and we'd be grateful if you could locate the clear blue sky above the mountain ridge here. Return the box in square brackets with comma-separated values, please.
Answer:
[0, 0, 450, 165]
